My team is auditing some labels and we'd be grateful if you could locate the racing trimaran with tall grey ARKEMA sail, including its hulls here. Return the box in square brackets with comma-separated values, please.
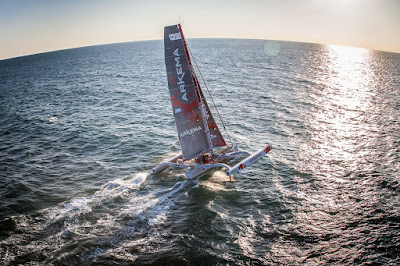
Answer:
[153, 24, 272, 179]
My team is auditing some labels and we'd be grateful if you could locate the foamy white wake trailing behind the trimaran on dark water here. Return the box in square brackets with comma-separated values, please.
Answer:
[0, 173, 196, 265]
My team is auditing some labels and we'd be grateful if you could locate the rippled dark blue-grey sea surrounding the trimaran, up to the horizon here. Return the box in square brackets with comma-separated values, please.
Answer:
[0, 39, 400, 265]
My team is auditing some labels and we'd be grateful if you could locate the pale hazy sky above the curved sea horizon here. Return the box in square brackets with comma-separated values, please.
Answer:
[0, 0, 400, 59]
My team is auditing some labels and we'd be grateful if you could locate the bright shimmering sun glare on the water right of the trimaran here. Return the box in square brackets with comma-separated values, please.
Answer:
[284, 42, 392, 264]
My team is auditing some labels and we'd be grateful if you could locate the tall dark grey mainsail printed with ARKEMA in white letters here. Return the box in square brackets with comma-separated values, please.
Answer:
[164, 25, 212, 160]
